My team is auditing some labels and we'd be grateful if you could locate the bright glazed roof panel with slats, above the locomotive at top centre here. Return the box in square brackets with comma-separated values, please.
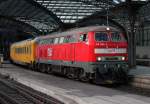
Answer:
[35, 0, 124, 23]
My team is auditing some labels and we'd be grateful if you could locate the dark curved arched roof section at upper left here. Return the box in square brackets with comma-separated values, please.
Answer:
[0, 0, 63, 30]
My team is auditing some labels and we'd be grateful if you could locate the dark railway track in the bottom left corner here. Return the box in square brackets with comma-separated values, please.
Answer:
[0, 77, 64, 104]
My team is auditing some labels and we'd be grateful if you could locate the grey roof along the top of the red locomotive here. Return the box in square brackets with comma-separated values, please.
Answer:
[38, 26, 119, 39]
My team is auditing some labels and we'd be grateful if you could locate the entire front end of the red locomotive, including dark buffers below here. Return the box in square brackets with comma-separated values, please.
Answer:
[88, 28, 128, 83]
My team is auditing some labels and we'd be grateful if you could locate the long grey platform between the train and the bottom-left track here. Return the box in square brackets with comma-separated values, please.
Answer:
[0, 63, 150, 104]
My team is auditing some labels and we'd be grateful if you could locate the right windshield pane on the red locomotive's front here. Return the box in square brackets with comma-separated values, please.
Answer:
[111, 32, 125, 42]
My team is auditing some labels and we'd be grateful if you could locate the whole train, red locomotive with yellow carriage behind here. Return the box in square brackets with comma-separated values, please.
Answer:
[10, 26, 128, 84]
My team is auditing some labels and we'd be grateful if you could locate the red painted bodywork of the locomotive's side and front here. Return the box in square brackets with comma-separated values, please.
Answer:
[36, 26, 128, 62]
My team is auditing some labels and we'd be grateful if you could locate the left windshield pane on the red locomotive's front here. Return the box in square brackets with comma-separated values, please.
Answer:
[95, 32, 108, 41]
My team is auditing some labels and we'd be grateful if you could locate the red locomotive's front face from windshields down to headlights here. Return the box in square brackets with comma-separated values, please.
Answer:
[94, 31, 128, 61]
